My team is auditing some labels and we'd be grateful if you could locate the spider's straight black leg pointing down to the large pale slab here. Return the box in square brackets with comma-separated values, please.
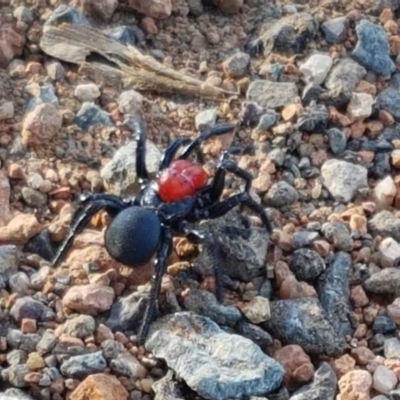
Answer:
[138, 226, 172, 344]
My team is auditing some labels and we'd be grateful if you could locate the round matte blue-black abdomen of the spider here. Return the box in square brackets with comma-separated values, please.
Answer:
[104, 206, 161, 268]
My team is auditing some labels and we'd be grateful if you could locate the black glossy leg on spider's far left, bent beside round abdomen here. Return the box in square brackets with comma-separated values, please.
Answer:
[51, 193, 128, 267]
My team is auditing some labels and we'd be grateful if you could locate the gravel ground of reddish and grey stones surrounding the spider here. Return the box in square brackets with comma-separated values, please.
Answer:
[0, 0, 400, 400]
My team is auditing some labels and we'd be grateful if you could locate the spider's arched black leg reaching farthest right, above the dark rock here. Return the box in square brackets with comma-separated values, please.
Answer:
[203, 192, 272, 233]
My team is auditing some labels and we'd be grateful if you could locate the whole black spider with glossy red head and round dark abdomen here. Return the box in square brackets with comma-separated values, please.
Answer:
[52, 119, 271, 344]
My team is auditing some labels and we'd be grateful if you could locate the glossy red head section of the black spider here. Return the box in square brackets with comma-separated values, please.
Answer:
[157, 160, 208, 203]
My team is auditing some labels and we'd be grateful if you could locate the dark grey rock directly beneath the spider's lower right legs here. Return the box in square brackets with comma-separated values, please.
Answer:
[194, 209, 268, 282]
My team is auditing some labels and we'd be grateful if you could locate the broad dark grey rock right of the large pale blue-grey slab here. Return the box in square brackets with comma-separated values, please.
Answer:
[262, 297, 343, 355]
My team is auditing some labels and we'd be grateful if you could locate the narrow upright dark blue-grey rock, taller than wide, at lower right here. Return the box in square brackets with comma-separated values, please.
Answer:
[316, 252, 353, 338]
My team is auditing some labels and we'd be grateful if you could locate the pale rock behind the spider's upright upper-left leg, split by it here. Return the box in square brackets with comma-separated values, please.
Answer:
[100, 136, 161, 196]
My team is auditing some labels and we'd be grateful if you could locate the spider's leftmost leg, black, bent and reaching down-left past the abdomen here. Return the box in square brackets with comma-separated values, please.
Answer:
[51, 200, 126, 267]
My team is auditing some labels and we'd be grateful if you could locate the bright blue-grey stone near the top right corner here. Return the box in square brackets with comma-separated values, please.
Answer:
[352, 19, 396, 76]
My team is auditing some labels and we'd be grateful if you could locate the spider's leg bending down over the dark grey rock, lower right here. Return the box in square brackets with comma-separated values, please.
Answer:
[180, 222, 224, 303]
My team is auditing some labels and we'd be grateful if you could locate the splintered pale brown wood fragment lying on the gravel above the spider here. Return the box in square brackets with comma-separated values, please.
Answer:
[40, 23, 238, 99]
